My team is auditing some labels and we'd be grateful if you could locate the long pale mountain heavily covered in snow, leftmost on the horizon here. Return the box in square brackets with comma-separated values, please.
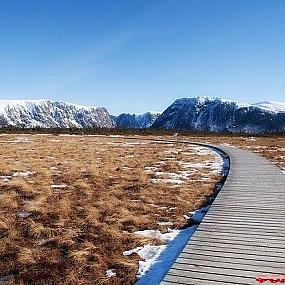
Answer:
[0, 100, 115, 128]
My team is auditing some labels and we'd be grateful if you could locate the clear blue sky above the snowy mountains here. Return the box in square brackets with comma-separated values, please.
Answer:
[0, 0, 285, 114]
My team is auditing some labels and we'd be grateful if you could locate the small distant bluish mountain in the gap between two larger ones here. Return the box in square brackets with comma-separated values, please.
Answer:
[112, 112, 161, 129]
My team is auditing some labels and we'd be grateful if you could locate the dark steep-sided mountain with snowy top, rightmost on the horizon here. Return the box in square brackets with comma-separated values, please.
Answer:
[152, 97, 285, 133]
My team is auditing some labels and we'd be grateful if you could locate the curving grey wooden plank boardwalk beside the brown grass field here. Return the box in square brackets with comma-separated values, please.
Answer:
[161, 147, 285, 285]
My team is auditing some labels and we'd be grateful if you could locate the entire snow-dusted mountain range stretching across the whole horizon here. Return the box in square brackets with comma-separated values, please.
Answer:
[0, 97, 285, 133]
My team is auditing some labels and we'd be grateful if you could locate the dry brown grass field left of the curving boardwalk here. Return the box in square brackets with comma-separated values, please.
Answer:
[0, 135, 220, 285]
